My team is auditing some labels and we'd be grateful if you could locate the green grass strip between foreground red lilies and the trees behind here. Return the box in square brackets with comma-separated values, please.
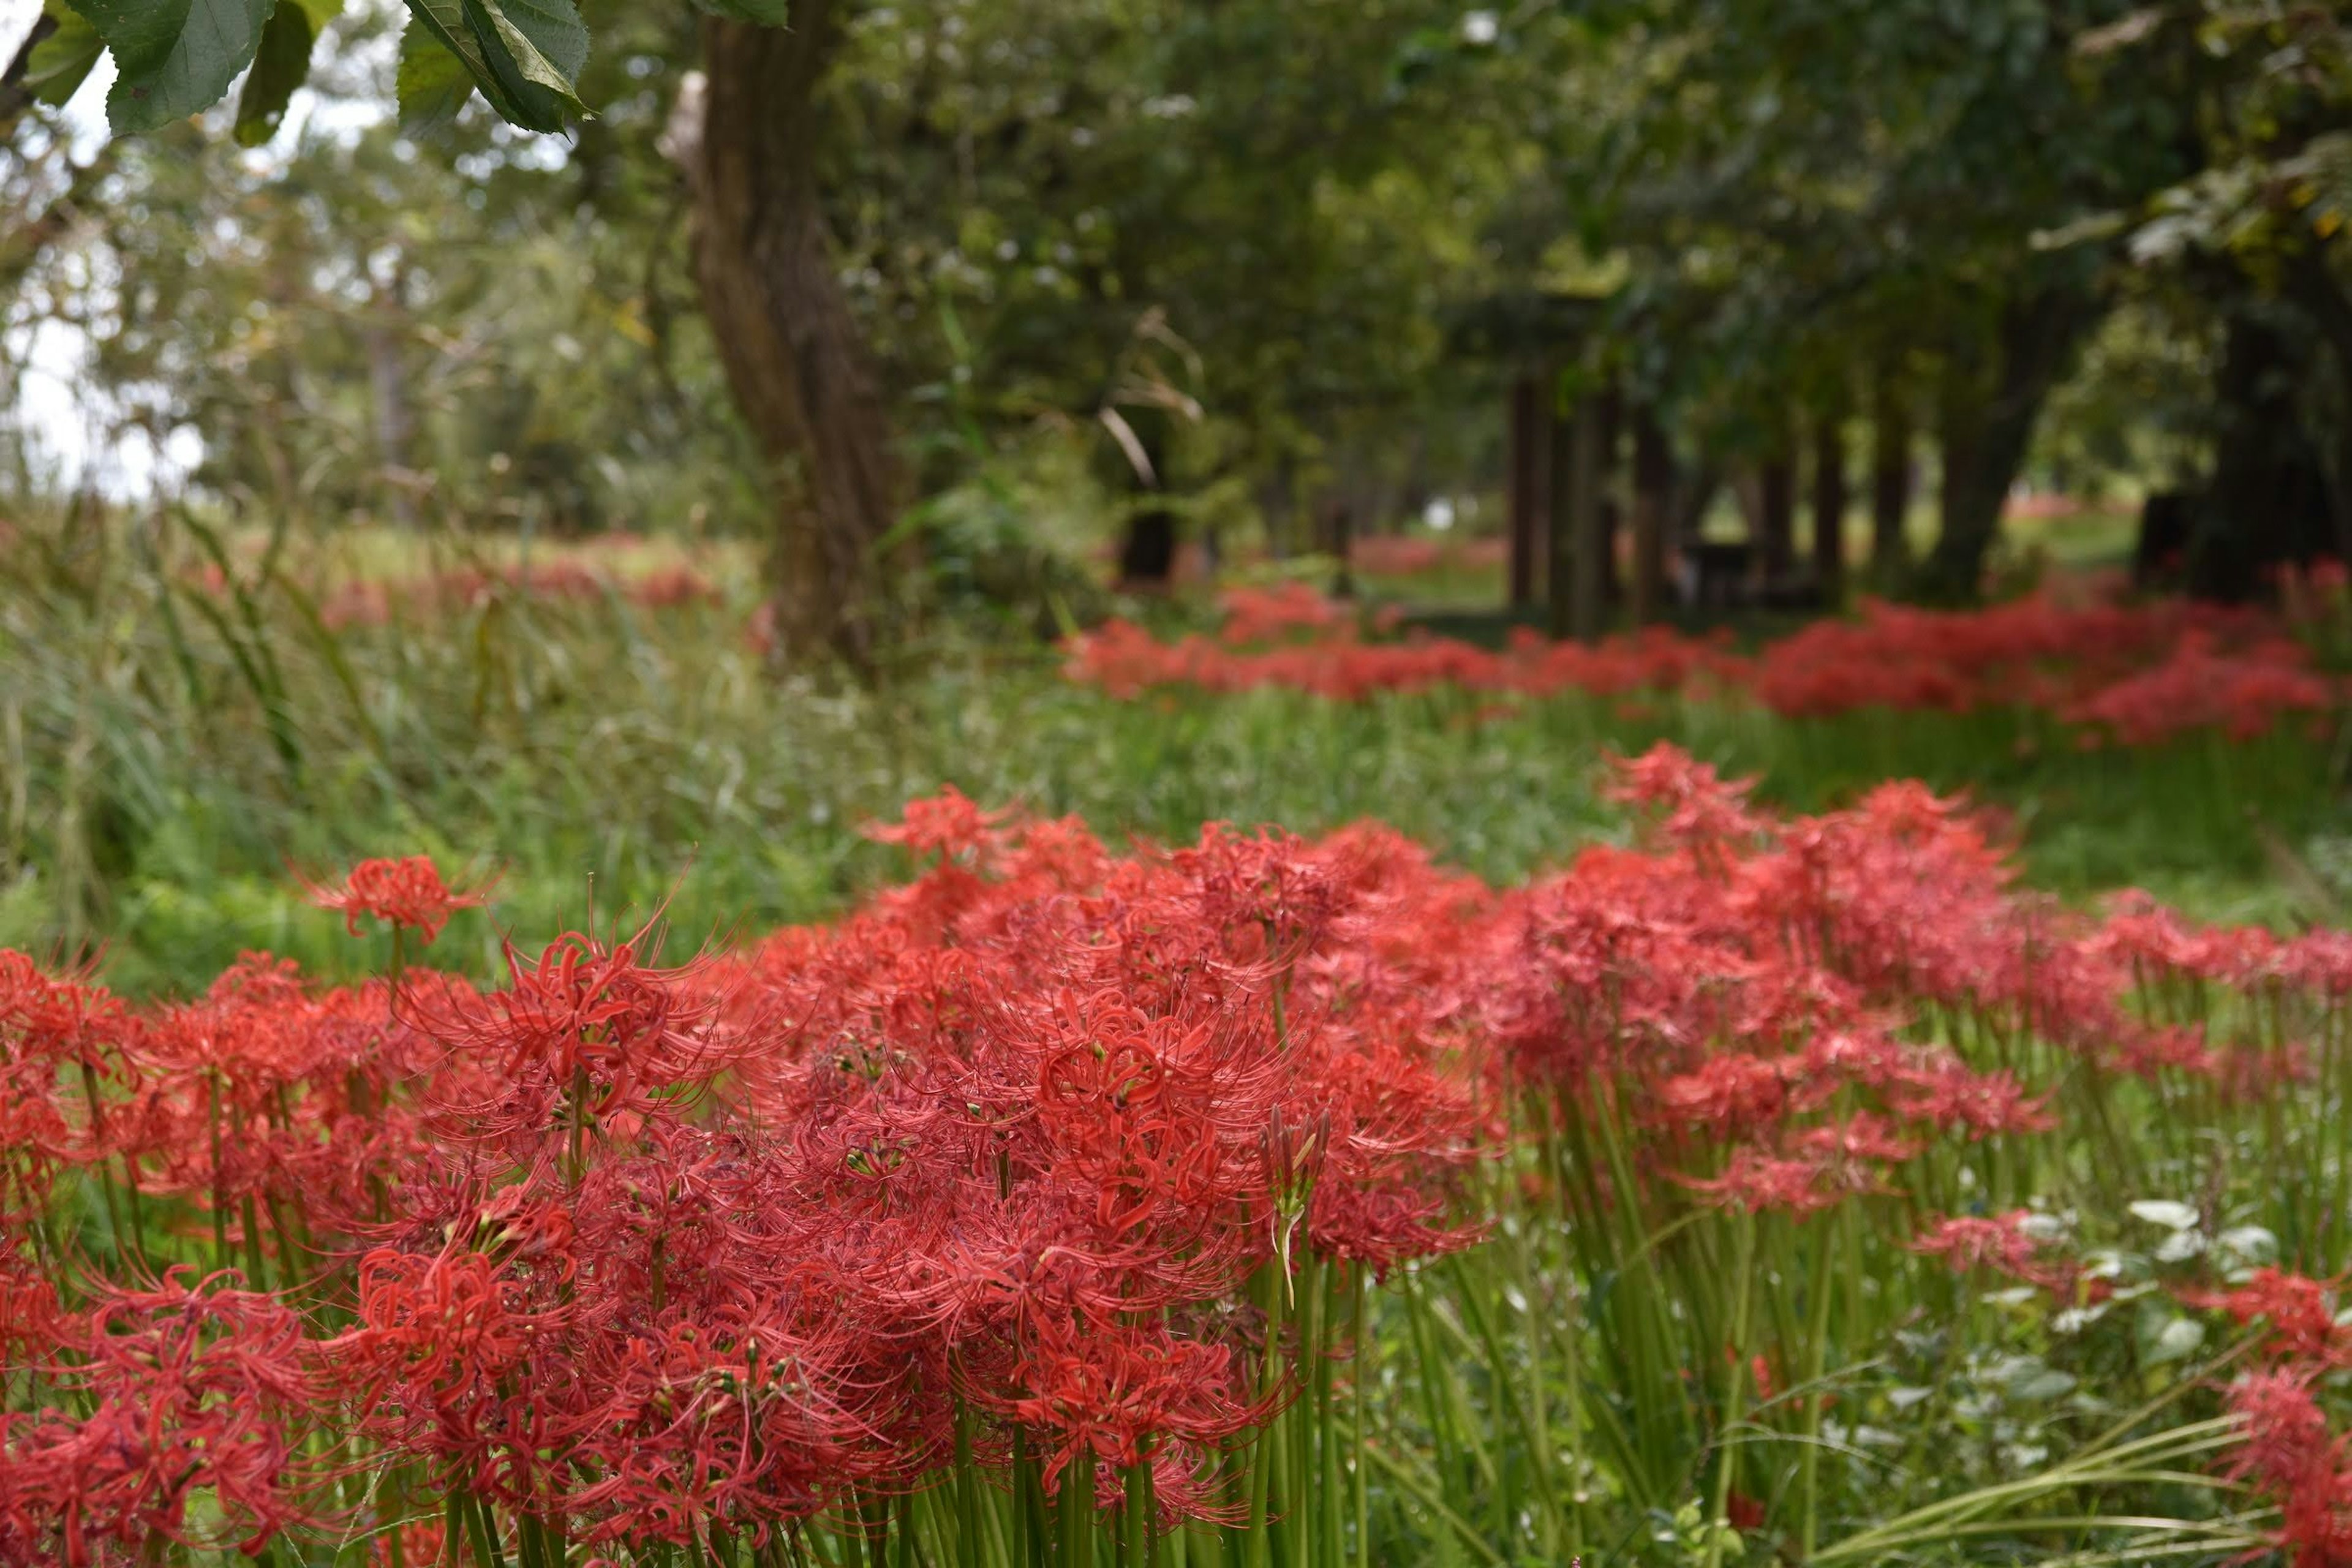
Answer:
[0, 512, 2347, 992]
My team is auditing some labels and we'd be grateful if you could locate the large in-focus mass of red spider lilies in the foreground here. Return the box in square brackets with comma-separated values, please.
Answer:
[0, 748, 2352, 1566]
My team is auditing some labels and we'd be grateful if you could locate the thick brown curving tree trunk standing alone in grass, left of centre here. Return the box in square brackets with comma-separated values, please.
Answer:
[680, 0, 903, 665]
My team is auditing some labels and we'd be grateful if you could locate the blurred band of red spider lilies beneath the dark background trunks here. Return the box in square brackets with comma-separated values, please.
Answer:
[1068, 588, 2343, 745]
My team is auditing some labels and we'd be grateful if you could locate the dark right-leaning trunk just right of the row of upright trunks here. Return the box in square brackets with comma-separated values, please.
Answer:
[1919, 284, 2098, 604]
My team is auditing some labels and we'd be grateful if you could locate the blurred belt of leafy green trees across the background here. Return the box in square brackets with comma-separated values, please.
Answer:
[0, 0, 2352, 661]
